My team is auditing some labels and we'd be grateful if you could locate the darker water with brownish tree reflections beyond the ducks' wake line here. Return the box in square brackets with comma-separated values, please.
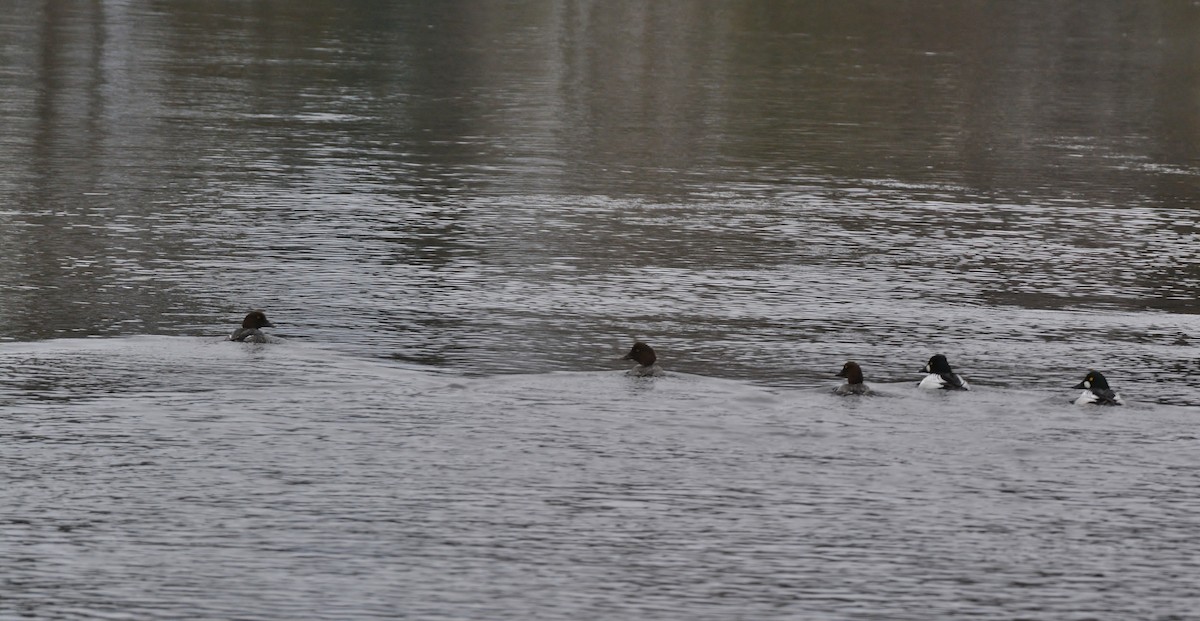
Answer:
[0, 1, 1200, 386]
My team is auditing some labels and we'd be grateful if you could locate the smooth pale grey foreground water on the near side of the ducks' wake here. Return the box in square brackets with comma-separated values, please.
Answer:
[0, 337, 1200, 619]
